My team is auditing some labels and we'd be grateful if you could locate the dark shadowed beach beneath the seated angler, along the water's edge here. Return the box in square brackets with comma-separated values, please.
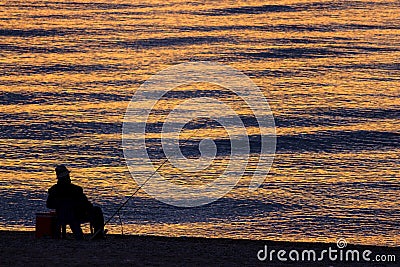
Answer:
[0, 231, 400, 266]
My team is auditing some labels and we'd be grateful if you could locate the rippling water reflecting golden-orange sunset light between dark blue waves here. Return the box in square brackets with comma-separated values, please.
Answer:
[0, 0, 400, 246]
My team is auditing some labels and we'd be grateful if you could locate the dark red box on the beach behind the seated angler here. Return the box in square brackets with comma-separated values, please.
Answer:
[35, 212, 60, 238]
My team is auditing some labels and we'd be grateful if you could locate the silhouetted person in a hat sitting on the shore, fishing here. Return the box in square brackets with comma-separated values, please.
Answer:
[46, 165, 105, 240]
